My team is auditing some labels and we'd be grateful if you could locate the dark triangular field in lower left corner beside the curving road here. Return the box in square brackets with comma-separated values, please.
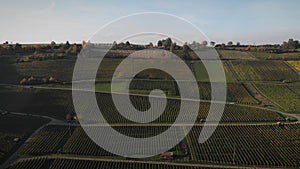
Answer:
[0, 114, 49, 163]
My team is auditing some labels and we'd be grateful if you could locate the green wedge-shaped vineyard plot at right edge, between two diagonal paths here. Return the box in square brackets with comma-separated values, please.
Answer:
[256, 84, 300, 113]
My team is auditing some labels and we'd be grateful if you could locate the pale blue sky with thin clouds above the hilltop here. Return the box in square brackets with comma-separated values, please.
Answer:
[0, 0, 300, 44]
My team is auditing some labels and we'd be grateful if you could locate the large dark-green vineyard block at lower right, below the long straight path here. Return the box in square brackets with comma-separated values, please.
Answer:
[188, 124, 300, 168]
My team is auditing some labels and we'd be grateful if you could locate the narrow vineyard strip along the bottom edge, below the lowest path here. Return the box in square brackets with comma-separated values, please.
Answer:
[8, 158, 213, 169]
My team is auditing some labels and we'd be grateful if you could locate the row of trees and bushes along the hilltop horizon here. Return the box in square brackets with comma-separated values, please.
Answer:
[0, 37, 300, 62]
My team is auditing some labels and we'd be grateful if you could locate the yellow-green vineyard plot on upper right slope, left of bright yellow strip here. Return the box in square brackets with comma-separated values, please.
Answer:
[228, 60, 300, 82]
